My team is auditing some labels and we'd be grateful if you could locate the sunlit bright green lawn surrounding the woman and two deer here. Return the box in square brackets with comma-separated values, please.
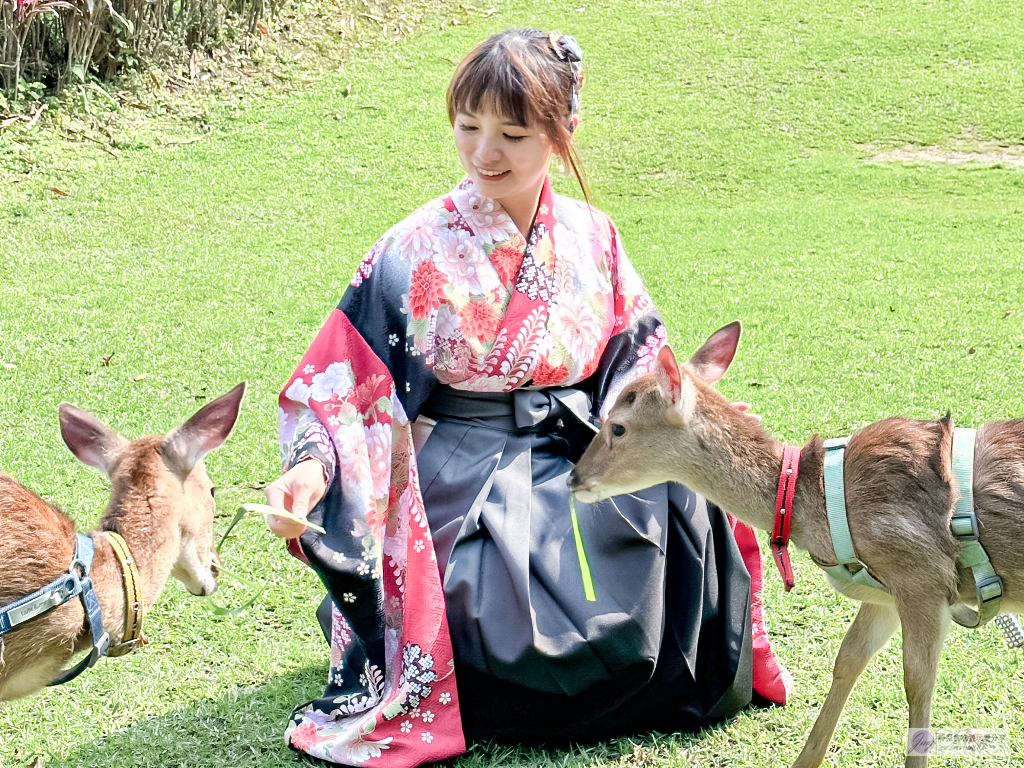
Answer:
[0, 0, 1024, 768]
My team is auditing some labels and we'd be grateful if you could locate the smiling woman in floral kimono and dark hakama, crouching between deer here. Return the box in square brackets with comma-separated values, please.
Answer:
[267, 30, 787, 766]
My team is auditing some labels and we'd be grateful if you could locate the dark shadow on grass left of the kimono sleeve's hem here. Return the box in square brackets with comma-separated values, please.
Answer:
[54, 667, 327, 768]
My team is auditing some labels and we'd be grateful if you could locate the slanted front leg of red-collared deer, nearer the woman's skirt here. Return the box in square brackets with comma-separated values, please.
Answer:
[793, 603, 899, 768]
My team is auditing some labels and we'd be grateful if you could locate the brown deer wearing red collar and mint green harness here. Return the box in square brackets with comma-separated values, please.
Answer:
[569, 322, 1024, 768]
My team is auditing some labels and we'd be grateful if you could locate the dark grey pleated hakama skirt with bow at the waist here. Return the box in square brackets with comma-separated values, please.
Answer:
[418, 388, 752, 743]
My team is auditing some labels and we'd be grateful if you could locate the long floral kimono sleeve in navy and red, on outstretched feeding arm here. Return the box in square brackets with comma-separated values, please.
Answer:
[280, 236, 465, 768]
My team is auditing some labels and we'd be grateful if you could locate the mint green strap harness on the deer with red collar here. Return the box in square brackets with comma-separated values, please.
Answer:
[822, 428, 1002, 629]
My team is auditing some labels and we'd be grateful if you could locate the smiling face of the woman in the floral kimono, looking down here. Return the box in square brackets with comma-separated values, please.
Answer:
[453, 105, 553, 218]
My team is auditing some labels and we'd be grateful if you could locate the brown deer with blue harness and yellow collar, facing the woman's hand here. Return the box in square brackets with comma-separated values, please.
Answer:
[0, 383, 246, 701]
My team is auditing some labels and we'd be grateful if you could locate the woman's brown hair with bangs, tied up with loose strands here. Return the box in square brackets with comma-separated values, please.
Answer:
[447, 28, 591, 203]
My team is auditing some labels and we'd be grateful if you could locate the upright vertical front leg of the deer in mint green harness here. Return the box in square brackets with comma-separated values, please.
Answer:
[900, 602, 949, 768]
